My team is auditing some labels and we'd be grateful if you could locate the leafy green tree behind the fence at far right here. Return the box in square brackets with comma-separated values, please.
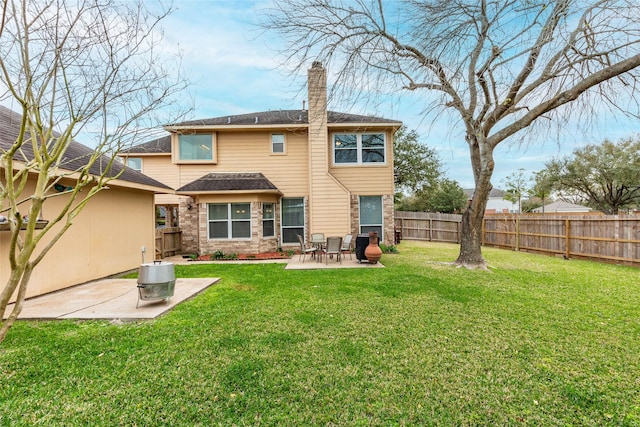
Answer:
[545, 137, 640, 215]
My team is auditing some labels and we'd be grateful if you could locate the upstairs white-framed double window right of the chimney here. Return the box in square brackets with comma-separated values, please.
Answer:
[333, 133, 387, 165]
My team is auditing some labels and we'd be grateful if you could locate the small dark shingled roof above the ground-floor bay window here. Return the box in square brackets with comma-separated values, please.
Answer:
[176, 173, 280, 194]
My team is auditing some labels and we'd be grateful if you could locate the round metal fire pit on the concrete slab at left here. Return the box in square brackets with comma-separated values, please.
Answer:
[136, 261, 176, 308]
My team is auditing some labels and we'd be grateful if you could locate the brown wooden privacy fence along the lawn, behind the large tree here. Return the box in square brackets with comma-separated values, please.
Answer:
[395, 212, 640, 267]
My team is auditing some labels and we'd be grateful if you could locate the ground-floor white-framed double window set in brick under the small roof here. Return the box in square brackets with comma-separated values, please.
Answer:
[207, 203, 251, 239]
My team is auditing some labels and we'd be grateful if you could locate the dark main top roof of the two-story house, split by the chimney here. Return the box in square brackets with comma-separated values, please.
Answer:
[165, 110, 402, 128]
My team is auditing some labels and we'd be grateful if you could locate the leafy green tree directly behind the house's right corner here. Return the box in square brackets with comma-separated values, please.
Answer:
[393, 126, 443, 192]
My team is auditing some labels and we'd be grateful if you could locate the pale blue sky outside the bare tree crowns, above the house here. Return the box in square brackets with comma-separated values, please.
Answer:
[5, 0, 640, 188]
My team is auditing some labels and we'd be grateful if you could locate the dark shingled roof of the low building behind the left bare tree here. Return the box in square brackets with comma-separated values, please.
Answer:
[0, 106, 171, 190]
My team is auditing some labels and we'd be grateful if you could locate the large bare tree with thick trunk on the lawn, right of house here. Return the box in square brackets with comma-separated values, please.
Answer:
[264, 0, 640, 267]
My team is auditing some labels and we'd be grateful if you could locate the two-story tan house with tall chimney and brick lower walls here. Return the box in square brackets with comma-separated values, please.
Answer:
[121, 62, 402, 254]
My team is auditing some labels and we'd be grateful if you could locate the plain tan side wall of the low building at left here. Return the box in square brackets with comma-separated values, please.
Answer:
[0, 179, 155, 297]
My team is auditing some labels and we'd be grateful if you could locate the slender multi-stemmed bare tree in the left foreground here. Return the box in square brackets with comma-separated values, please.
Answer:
[0, 0, 186, 341]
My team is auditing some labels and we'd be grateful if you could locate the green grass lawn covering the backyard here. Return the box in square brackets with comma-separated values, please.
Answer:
[0, 241, 640, 426]
